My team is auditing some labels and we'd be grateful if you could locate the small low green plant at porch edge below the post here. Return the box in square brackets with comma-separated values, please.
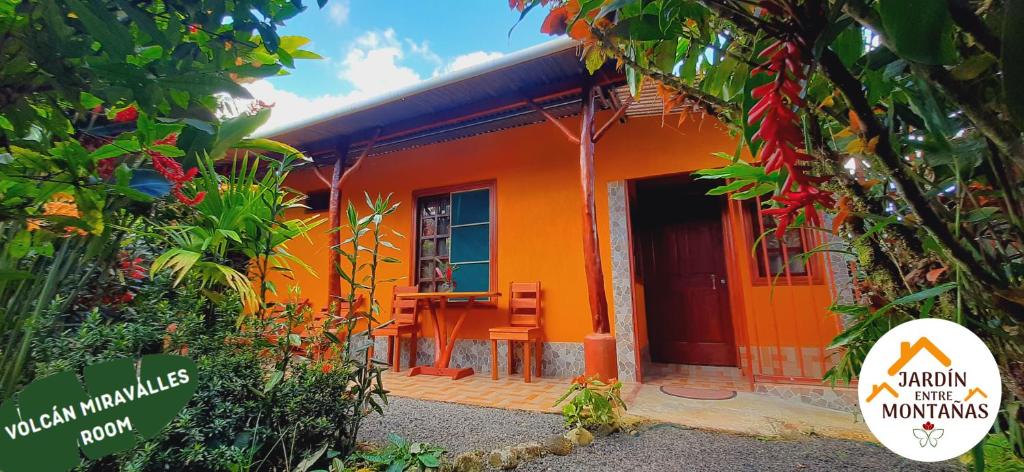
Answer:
[554, 376, 626, 428]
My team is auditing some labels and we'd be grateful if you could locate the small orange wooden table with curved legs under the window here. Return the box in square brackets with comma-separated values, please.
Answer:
[395, 292, 502, 380]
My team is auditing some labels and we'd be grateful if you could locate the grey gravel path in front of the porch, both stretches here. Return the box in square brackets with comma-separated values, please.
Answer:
[360, 397, 963, 471]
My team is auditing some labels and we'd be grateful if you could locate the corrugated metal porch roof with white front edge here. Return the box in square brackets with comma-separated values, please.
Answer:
[264, 39, 623, 159]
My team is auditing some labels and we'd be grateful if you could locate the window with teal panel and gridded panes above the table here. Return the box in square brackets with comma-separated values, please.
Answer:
[416, 187, 494, 292]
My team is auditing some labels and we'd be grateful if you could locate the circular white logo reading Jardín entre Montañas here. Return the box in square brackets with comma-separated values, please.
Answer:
[857, 318, 1002, 462]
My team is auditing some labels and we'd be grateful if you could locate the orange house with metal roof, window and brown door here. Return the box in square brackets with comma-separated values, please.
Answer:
[269, 40, 856, 410]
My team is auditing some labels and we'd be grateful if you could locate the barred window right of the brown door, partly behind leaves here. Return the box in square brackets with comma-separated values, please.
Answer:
[748, 202, 809, 278]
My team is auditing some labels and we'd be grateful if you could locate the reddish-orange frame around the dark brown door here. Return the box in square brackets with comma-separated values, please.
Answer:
[626, 172, 754, 385]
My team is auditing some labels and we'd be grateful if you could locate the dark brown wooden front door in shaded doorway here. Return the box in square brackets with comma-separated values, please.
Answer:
[634, 179, 736, 366]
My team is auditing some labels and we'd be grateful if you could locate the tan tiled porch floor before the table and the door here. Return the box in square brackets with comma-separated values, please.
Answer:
[384, 370, 874, 441]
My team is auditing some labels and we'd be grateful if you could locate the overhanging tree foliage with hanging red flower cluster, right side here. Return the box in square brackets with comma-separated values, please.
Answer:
[520, 0, 1024, 457]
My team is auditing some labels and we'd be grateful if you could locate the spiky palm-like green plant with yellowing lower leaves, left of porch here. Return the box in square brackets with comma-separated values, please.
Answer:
[151, 154, 323, 317]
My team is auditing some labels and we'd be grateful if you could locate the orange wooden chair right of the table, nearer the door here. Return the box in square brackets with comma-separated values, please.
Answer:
[489, 282, 544, 383]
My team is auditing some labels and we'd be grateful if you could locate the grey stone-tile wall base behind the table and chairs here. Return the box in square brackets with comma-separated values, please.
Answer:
[374, 337, 584, 378]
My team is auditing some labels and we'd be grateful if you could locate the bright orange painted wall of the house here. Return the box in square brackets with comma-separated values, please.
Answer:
[278, 115, 834, 364]
